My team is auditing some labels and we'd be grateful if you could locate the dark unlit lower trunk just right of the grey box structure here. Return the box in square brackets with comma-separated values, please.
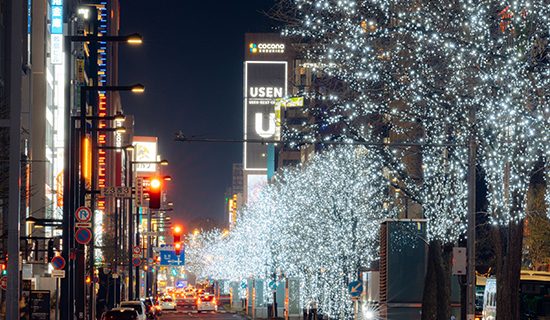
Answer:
[422, 240, 451, 320]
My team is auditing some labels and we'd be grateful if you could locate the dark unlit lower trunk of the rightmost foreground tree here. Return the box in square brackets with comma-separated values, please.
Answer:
[494, 220, 523, 320]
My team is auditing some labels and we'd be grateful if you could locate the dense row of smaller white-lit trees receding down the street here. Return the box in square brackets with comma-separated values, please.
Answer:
[186, 146, 392, 318]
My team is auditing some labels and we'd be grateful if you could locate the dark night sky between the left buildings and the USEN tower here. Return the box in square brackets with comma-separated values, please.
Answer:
[119, 0, 276, 229]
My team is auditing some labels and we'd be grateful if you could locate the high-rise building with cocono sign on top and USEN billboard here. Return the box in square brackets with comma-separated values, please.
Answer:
[243, 33, 293, 203]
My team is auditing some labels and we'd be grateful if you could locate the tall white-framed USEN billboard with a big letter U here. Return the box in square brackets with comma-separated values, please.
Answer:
[244, 61, 288, 170]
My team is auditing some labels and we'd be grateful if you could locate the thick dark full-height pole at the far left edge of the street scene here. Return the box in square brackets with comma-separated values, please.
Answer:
[2, 0, 23, 319]
